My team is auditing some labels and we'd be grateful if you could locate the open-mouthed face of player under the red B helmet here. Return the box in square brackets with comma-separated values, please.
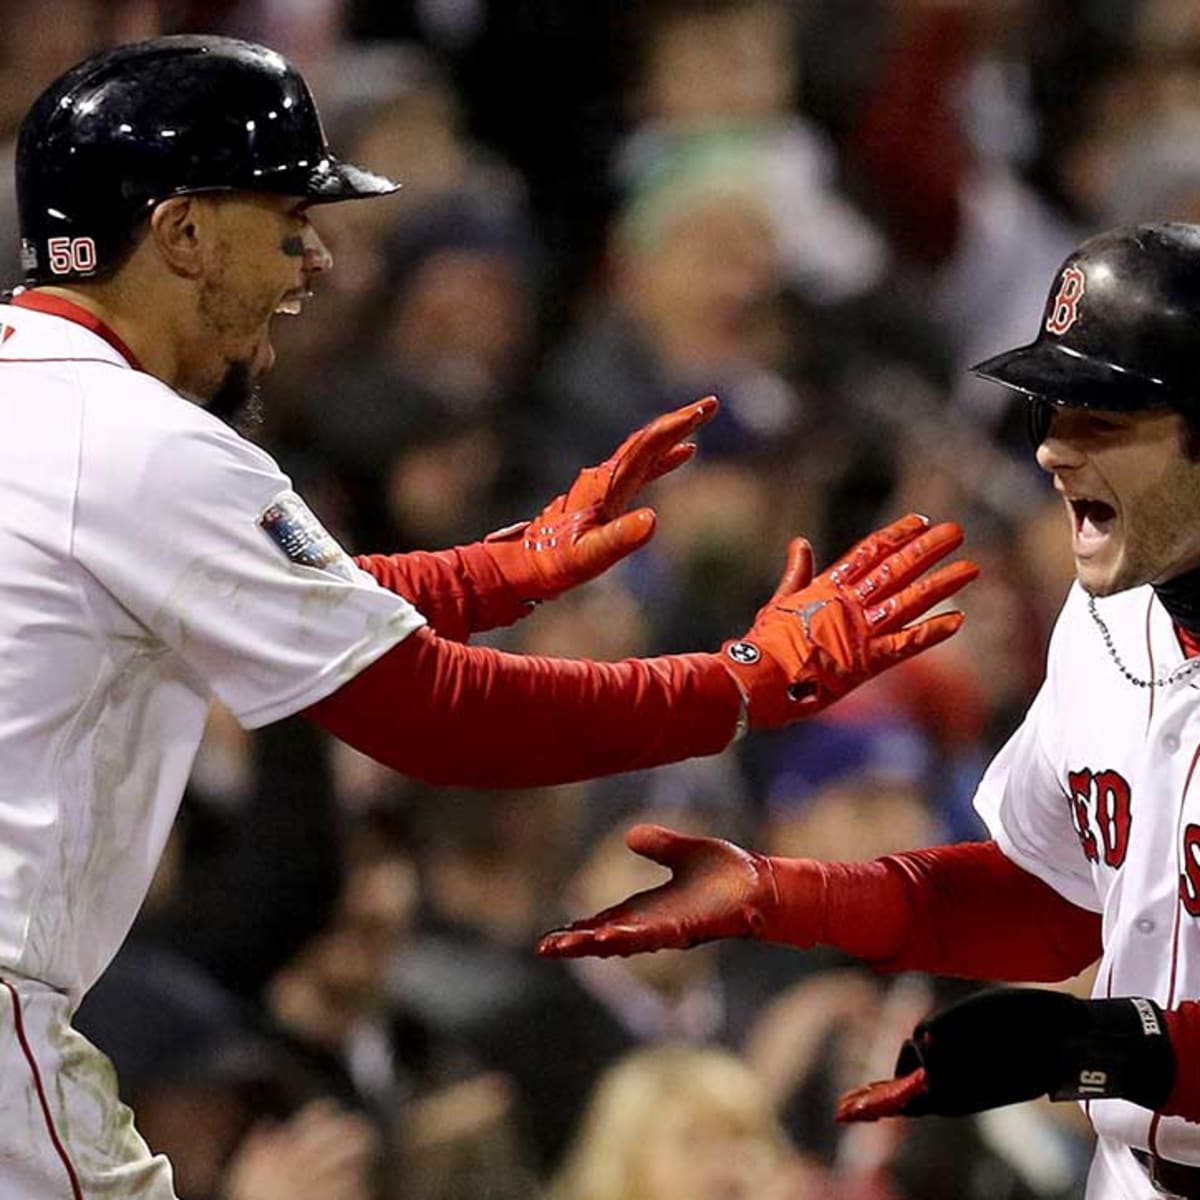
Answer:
[1037, 408, 1200, 596]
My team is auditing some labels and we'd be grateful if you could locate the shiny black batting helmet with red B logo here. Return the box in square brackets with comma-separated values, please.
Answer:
[971, 222, 1200, 440]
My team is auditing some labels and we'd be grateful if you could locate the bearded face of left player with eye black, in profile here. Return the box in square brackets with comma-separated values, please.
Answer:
[193, 192, 332, 415]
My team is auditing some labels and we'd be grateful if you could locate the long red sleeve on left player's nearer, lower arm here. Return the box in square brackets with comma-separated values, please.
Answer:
[305, 629, 742, 787]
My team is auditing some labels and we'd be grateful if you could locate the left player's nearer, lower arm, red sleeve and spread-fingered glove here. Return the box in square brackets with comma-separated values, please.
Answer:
[306, 516, 976, 787]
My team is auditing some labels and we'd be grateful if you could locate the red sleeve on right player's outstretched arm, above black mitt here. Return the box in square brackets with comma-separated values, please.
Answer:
[772, 841, 1103, 983]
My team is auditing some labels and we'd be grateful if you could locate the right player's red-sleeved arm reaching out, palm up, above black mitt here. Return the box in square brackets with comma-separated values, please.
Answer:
[538, 826, 1102, 982]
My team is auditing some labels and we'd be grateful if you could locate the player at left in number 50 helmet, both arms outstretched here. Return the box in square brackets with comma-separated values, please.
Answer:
[0, 37, 974, 1200]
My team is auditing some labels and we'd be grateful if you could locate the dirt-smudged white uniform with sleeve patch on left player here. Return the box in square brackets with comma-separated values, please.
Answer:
[0, 294, 424, 1200]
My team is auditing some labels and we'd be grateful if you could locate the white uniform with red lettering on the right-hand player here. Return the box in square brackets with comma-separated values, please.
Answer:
[976, 584, 1200, 1200]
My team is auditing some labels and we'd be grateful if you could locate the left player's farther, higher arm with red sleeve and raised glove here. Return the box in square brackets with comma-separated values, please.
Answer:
[355, 396, 718, 642]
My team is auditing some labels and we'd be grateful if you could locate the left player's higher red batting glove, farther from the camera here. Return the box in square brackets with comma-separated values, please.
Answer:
[480, 396, 718, 604]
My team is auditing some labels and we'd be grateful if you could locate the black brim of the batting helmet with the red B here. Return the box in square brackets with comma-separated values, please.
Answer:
[971, 341, 1180, 413]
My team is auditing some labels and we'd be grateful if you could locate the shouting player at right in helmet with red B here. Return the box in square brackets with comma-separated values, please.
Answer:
[540, 224, 1200, 1200]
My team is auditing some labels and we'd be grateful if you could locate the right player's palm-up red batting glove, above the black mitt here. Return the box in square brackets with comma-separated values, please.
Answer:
[538, 824, 824, 958]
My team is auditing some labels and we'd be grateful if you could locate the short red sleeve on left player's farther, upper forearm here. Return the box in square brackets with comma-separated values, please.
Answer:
[354, 542, 530, 642]
